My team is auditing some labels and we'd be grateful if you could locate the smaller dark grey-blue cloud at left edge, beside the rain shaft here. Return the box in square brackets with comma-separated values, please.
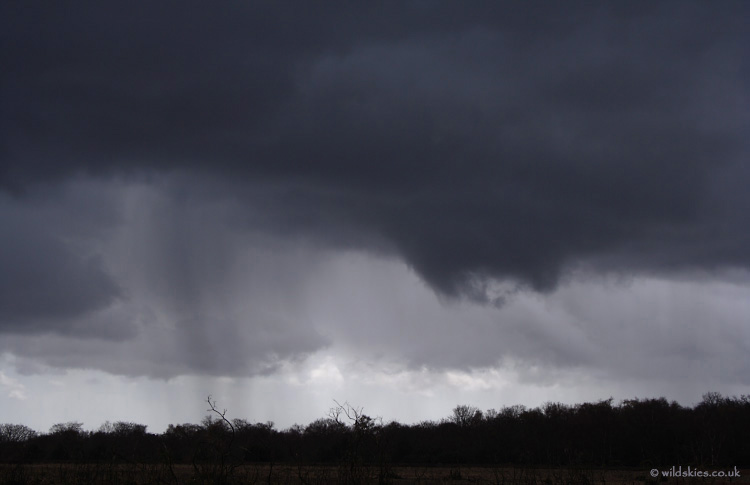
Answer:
[0, 185, 128, 338]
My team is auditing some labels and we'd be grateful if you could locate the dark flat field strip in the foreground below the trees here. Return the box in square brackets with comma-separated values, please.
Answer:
[0, 464, 750, 485]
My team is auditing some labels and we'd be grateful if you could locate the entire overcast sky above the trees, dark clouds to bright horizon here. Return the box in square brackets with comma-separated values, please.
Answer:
[0, 1, 750, 432]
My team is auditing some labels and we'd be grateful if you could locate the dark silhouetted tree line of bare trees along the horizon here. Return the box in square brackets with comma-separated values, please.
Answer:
[0, 393, 750, 466]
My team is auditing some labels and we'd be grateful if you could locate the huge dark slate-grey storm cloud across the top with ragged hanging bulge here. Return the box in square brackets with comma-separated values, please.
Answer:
[0, 2, 750, 300]
